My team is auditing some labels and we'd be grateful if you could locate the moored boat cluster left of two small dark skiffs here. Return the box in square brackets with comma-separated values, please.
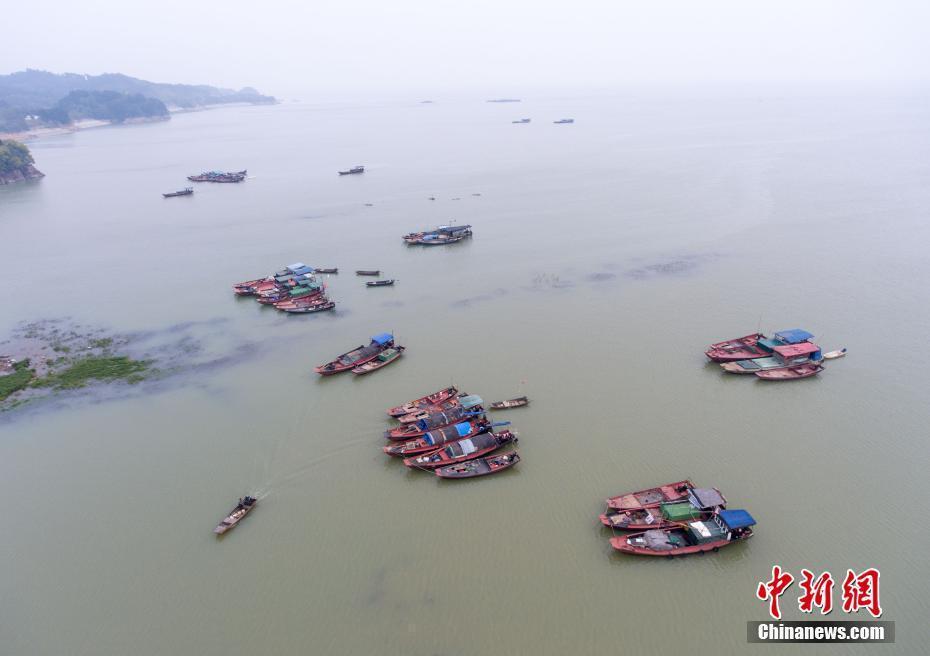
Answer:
[233, 262, 338, 314]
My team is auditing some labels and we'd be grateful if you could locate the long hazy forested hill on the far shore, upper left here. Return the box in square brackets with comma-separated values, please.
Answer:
[0, 70, 276, 132]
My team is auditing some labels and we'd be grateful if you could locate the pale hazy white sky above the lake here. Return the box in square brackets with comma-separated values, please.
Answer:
[0, 0, 930, 100]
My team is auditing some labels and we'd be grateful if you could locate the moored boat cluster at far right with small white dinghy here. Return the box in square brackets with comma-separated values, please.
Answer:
[704, 328, 846, 380]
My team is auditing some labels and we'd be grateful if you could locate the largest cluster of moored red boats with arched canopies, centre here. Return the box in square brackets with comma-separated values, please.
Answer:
[383, 386, 529, 478]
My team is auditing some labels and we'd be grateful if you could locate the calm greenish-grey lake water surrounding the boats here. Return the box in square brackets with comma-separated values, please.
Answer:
[0, 92, 930, 656]
